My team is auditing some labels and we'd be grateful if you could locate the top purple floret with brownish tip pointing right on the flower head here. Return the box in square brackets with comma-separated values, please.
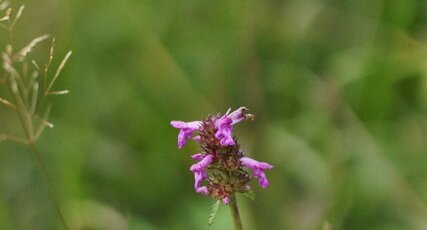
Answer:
[215, 107, 253, 146]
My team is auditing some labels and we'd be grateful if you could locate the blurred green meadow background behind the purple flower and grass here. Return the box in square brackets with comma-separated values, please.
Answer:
[0, 0, 427, 230]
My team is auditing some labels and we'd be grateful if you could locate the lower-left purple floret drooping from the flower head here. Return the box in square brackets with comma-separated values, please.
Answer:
[190, 154, 214, 194]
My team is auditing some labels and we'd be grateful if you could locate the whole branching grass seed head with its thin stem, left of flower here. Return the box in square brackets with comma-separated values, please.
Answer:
[0, 0, 71, 229]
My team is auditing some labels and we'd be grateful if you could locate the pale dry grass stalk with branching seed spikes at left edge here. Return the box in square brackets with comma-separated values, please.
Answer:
[0, 4, 71, 230]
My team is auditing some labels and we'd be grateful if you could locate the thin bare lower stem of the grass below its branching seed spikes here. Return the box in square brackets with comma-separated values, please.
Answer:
[29, 143, 69, 230]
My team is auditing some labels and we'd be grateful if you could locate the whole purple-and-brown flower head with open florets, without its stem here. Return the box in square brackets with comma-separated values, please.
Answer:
[171, 107, 273, 204]
